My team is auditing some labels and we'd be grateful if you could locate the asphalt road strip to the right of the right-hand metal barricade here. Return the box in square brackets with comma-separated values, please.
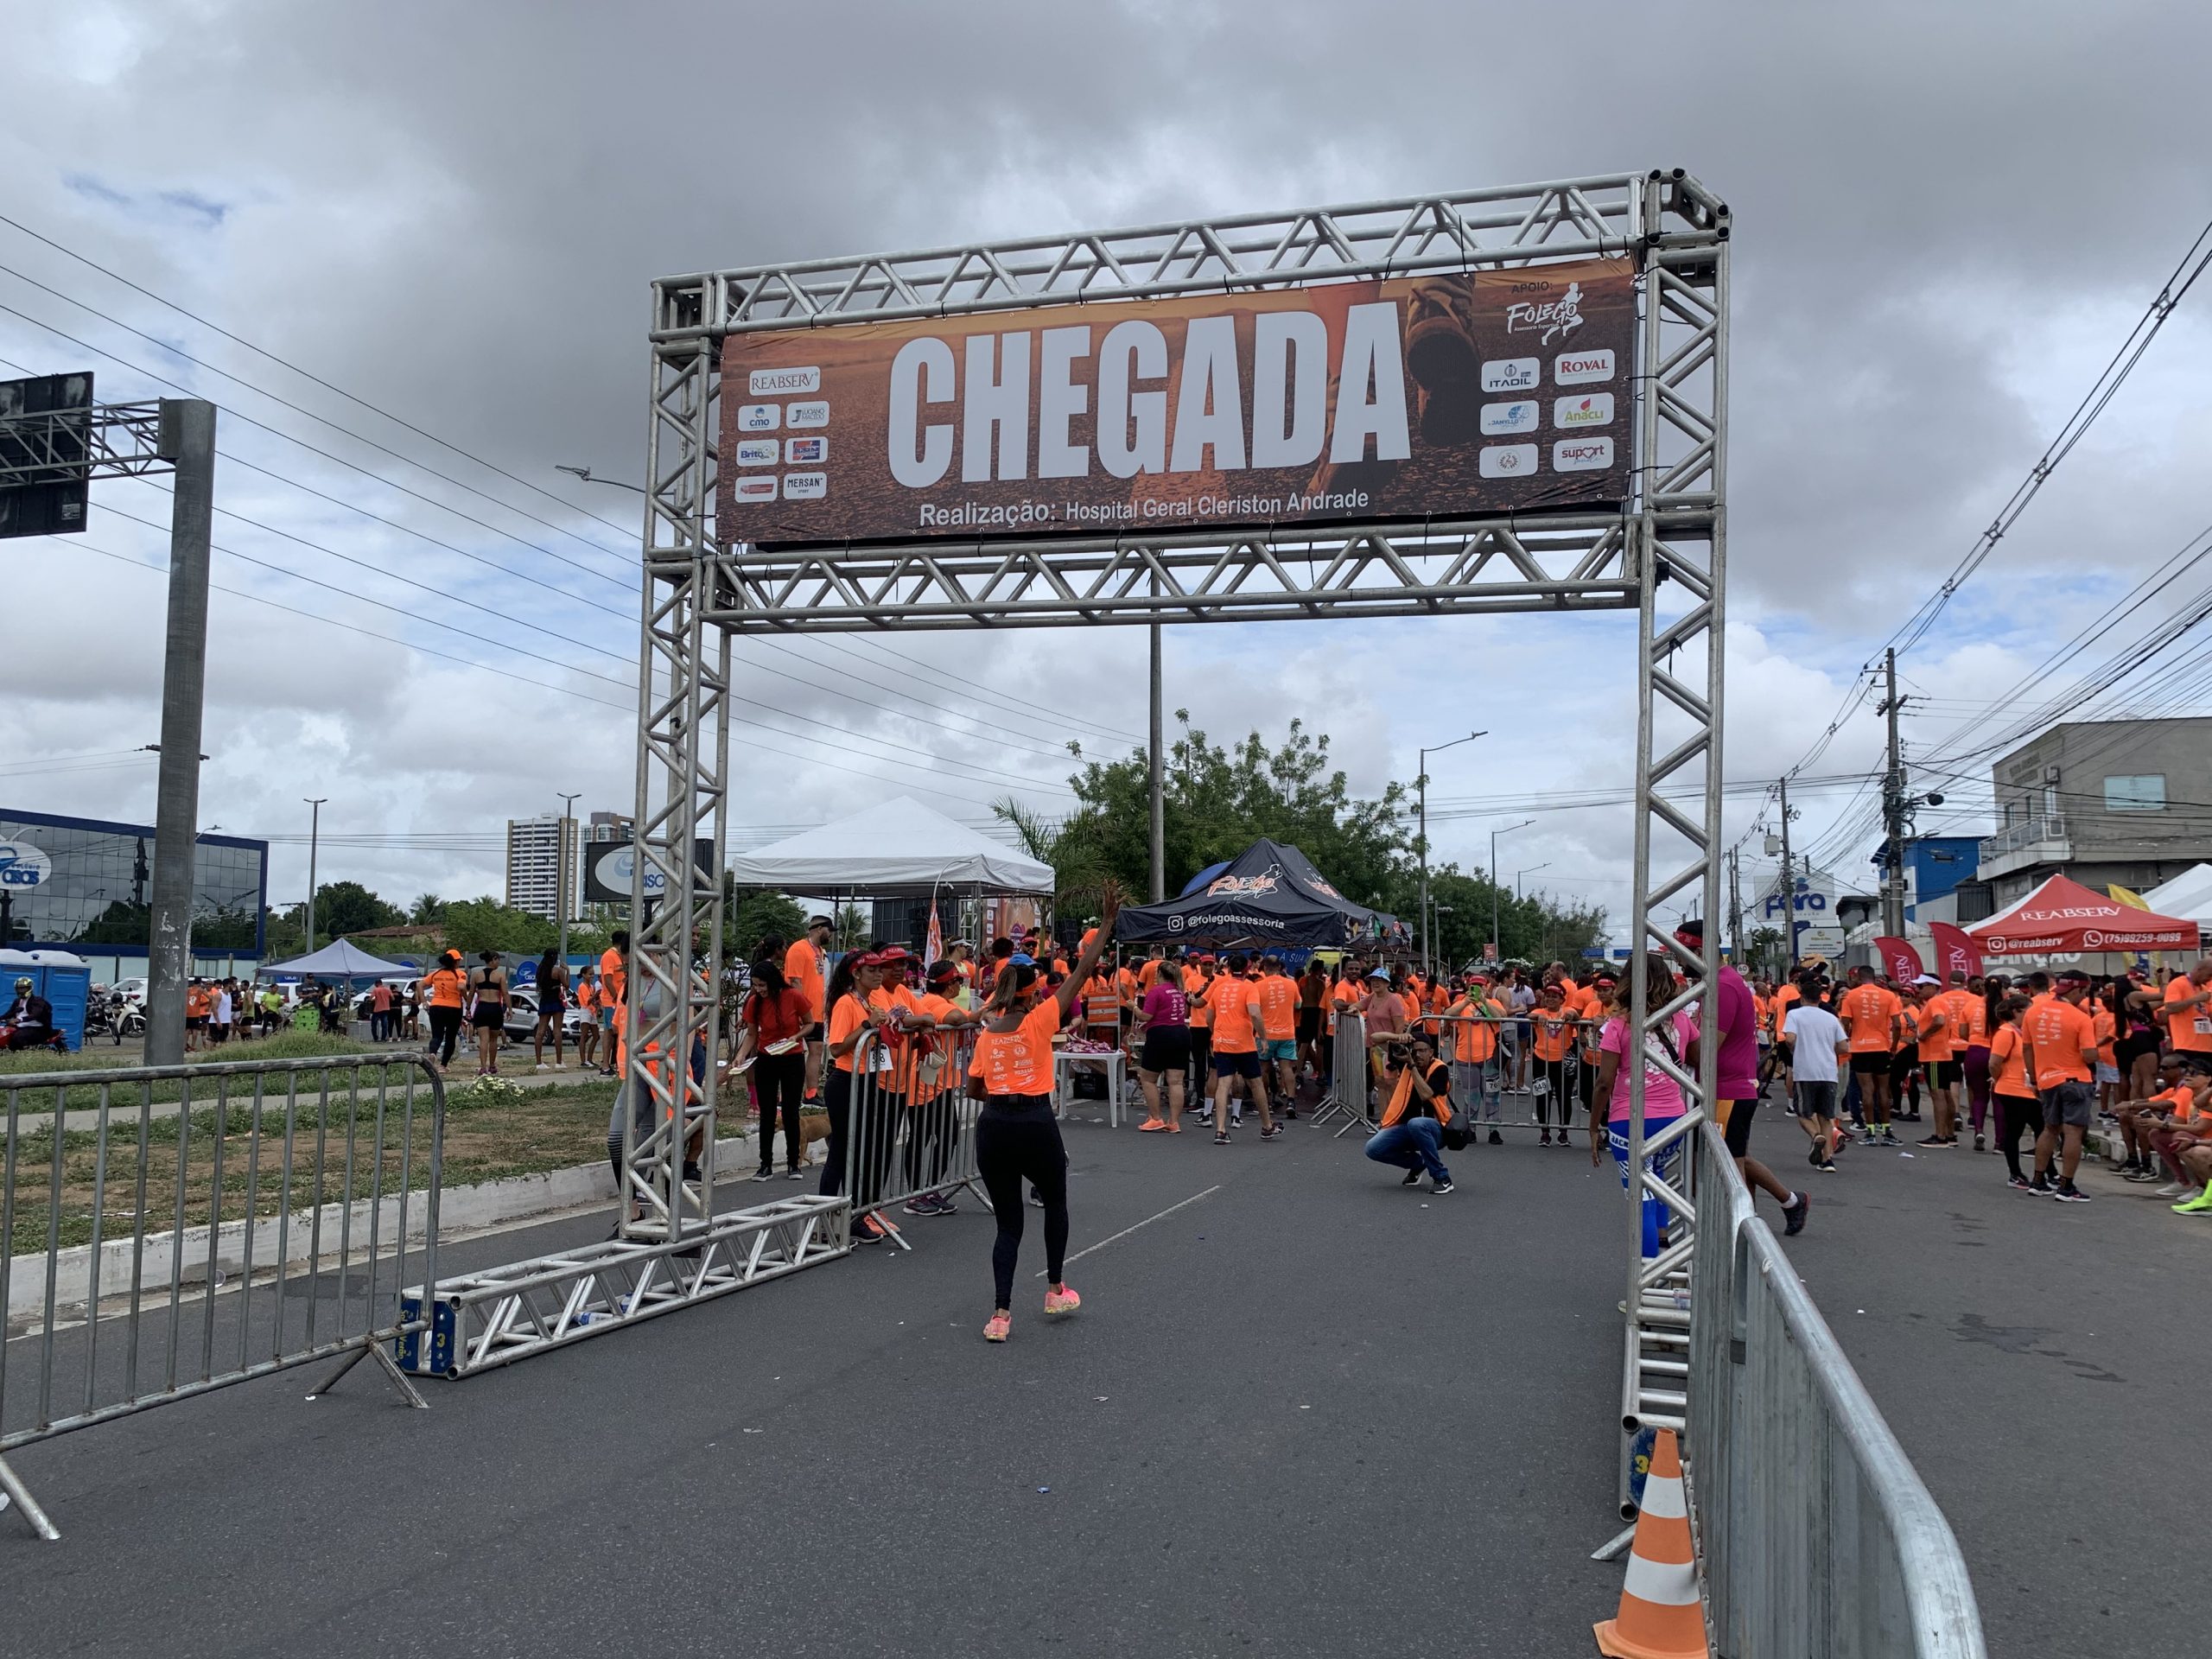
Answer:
[1752, 1106, 2212, 1659]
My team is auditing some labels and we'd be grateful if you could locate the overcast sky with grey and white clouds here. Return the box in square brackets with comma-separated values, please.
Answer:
[0, 0, 2212, 938]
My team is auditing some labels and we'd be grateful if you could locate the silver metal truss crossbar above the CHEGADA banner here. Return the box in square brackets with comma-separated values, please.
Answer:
[655, 173, 1643, 343]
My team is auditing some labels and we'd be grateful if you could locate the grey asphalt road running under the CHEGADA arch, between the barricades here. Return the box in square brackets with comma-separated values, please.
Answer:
[0, 1123, 1645, 1659]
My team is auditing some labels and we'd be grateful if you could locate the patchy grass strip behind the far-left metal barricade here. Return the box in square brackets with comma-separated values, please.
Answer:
[13, 1079, 615, 1256]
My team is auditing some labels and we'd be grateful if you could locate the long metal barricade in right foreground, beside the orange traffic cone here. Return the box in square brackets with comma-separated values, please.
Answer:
[1683, 1123, 1986, 1659]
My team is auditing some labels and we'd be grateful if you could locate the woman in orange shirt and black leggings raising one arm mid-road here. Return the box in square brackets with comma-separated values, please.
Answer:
[969, 889, 1119, 1343]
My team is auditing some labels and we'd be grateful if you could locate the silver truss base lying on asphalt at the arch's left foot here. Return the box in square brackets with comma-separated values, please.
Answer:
[400, 1194, 852, 1376]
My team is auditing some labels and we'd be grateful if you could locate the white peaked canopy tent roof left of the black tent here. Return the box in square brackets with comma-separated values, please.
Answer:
[730, 797, 1053, 898]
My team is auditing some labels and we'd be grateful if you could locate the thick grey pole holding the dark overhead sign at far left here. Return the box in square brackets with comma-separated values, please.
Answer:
[146, 409, 214, 1066]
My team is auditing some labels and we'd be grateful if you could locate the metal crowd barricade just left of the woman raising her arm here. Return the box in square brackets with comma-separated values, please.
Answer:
[842, 1027, 988, 1249]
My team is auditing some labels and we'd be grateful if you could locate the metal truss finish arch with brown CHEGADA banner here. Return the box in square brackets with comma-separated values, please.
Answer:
[626, 170, 1730, 1546]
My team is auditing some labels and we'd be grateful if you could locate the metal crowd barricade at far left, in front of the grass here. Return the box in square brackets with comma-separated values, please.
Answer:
[0, 1051, 445, 1540]
